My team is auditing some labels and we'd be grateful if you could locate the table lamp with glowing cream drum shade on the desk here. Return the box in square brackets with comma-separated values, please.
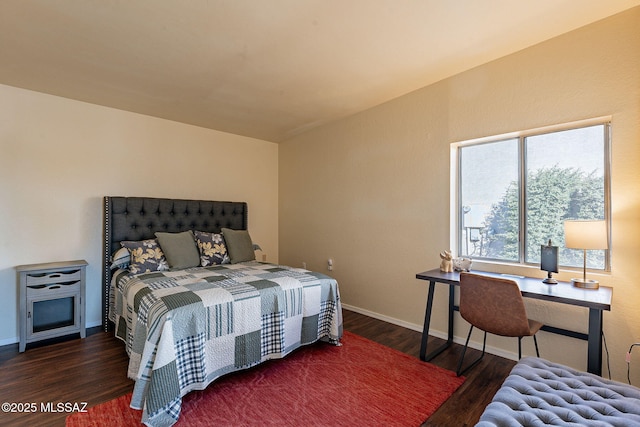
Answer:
[564, 220, 609, 289]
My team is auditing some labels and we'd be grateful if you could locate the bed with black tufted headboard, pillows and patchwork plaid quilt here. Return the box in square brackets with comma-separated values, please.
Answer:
[103, 197, 342, 426]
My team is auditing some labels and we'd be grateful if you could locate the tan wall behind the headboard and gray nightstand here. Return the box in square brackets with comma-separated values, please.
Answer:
[0, 85, 278, 345]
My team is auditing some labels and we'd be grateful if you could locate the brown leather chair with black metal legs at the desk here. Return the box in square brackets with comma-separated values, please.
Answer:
[456, 272, 543, 376]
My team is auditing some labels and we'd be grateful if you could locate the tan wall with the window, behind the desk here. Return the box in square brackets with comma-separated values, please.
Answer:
[279, 8, 640, 384]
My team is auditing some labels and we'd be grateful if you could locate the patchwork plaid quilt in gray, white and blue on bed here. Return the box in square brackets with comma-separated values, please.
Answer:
[109, 262, 342, 426]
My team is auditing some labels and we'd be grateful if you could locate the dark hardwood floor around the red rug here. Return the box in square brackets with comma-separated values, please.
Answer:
[0, 310, 515, 427]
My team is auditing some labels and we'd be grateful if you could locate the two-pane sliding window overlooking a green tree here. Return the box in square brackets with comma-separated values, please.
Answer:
[453, 120, 610, 270]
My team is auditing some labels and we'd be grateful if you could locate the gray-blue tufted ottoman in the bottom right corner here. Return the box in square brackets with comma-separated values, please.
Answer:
[476, 357, 640, 427]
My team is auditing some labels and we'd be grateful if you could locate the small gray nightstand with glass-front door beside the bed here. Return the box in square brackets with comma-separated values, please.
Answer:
[16, 260, 87, 352]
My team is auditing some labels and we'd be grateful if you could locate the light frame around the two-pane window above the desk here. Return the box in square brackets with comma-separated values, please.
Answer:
[450, 116, 612, 272]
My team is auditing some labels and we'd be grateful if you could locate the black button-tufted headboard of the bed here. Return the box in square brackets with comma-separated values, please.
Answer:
[102, 196, 247, 331]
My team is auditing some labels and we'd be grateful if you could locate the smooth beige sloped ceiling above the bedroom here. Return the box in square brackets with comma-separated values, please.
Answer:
[0, 0, 640, 142]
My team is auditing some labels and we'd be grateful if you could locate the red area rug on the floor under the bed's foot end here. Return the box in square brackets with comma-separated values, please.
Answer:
[66, 332, 464, 427]
